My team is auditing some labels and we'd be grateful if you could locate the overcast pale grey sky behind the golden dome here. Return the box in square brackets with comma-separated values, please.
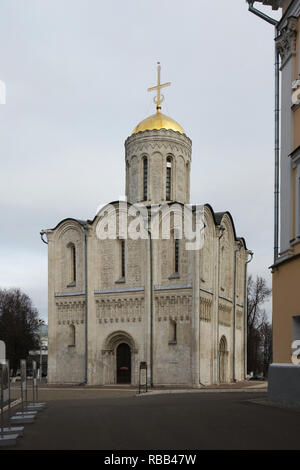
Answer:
[0, 0, 278, 319]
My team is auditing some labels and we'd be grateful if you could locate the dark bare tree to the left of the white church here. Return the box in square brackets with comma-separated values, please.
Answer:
[0, 289, 40, 373]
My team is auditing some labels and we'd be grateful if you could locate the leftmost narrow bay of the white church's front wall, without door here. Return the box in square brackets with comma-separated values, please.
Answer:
[48, 219, 84, 383]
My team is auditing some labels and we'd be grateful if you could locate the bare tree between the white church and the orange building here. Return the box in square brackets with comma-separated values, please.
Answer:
[247, 276, 272, 374]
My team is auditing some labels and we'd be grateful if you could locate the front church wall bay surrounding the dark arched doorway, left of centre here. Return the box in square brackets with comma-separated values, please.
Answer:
[84, 209, 147, 384]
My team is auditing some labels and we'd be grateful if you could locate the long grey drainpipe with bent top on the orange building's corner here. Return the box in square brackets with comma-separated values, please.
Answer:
[247, 0, 280, 263]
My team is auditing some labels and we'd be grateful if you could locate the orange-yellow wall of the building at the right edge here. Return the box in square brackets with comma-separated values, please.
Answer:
[273, 0, 300, 363]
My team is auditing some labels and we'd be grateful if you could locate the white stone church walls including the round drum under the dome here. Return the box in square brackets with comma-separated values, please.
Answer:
[44, 122, 246, 386]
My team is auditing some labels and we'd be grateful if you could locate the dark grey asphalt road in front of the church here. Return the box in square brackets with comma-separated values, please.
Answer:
[2, 391, 300, 450]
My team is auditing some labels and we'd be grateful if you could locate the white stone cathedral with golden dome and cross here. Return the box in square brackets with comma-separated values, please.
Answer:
[41, 66, 250, 387]
